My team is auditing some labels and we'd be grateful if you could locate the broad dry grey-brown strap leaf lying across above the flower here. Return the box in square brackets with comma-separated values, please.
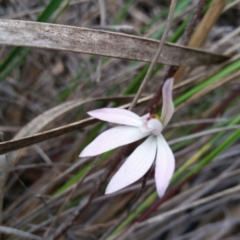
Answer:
[0, 19, 229, 67]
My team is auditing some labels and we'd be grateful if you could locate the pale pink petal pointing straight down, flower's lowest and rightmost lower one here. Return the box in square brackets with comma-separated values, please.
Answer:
[155, 135, 175, 197]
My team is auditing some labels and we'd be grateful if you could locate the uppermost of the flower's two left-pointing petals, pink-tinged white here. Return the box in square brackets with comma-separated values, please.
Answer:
[88, 108, 143, 127]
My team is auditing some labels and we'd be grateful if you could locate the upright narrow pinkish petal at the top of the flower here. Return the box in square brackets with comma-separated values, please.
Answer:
[161, 78, 174, 127]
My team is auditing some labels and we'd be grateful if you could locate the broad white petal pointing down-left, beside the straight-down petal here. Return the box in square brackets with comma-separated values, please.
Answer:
[106, 136, 157, 194]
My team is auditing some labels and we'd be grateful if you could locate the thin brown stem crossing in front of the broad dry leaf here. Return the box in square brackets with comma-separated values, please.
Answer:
[129, 0, 177, 110]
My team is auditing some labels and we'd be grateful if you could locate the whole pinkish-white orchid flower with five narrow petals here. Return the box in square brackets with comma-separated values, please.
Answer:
[80, 78, 175, 197]
